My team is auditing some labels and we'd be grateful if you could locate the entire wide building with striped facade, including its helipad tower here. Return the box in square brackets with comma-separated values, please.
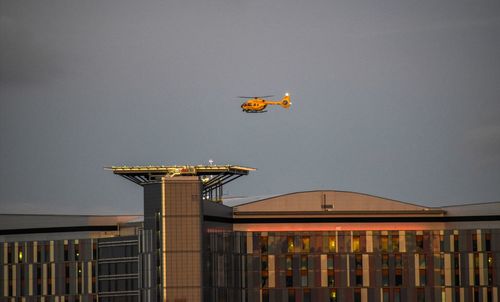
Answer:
[0, 166, 500, 302]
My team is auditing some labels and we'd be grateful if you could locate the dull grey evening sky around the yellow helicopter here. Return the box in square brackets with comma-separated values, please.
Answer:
[0, 0, 500, 213]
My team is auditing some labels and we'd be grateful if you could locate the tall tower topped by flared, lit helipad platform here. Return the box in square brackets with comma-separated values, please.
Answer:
[110, 166, 254, 302]
